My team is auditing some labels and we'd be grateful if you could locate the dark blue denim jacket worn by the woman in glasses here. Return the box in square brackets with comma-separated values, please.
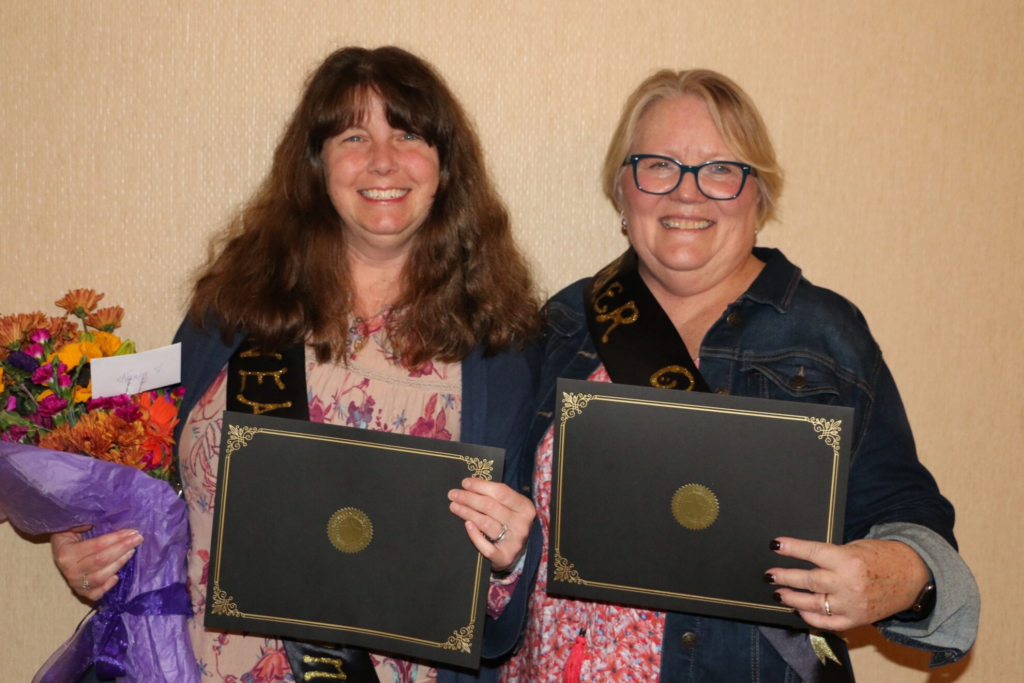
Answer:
[527, 249, 979, 683]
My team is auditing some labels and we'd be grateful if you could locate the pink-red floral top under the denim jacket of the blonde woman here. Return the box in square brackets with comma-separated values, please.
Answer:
[501, 366, 665, 683]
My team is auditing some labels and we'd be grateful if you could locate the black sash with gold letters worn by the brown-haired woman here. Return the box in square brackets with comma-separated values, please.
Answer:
[227, 340, 380, 683]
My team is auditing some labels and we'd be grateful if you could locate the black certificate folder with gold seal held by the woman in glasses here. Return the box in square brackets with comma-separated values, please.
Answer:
[548, 379, 853, 626]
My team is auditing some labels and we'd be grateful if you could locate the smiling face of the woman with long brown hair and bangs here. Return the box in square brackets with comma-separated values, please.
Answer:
[321, 95, 440, 259]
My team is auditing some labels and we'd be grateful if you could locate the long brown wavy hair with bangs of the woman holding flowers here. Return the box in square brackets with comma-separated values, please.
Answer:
[188, 47, 541, 367]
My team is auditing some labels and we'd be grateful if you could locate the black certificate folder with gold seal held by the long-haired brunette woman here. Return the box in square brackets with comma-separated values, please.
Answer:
[206, 412, 504, 669]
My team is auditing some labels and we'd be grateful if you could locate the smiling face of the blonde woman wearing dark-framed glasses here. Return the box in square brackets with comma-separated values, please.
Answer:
[618, 95, 758, 294]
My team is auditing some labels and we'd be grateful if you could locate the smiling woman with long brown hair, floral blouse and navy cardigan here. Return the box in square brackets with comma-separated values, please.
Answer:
[52, 47, 540, 683]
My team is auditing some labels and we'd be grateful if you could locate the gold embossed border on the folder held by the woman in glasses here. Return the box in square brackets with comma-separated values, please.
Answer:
[553, 392, 843, 612]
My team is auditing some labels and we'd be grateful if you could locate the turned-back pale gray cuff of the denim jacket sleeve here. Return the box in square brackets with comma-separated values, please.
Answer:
[867, 522, 981, 667]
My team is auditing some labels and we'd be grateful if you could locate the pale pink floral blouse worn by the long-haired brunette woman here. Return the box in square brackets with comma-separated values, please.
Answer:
[179, 315, 464, 683]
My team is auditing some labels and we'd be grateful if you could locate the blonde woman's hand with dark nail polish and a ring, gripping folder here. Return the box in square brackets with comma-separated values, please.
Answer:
[765, 538, 930, 631]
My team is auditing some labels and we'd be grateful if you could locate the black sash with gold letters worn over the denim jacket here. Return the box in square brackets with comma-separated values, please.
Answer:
[584, 248, 853, 683]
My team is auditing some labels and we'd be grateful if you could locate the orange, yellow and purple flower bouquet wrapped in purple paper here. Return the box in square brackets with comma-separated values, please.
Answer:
[0, 290, 199, 682]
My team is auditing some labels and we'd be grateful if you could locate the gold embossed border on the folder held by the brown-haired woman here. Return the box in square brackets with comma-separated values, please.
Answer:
[211, 425, 485, 654]
